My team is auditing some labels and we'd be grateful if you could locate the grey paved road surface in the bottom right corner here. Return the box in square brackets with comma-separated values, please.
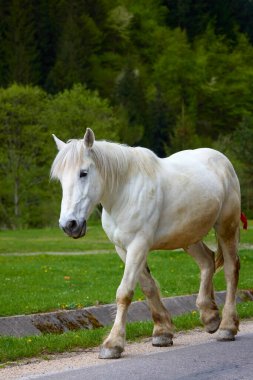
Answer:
[33, 333, 253, 380]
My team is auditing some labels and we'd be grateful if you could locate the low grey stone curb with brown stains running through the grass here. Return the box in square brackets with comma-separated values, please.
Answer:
[0, 290, 253, 337]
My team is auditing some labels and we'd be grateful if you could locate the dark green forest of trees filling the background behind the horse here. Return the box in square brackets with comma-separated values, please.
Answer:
[0, 0, 253, 229]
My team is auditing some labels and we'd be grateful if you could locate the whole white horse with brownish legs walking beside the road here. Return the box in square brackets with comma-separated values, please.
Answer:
[51, 128, 241, 359]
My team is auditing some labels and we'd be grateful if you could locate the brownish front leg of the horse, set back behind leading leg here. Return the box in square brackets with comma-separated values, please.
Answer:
[139, 266, 173, 347]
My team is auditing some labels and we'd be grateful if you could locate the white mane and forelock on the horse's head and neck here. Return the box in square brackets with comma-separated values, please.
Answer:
[51, 140, 159, 188]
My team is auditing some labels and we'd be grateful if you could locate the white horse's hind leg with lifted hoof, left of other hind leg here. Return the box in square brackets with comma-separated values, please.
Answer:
[187, 242, 220, 334]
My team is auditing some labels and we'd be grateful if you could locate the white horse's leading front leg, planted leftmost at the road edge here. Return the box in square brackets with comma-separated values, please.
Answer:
[99, 241, 148, 359]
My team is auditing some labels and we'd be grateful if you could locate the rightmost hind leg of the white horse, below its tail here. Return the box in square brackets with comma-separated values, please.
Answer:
[216, 221, 240, 340]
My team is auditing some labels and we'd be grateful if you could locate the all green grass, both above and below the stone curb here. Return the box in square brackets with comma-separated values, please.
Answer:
[0, 222, 253, 363]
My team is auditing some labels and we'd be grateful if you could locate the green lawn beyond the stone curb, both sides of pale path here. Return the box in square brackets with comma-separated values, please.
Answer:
[0, 223, 253, 316]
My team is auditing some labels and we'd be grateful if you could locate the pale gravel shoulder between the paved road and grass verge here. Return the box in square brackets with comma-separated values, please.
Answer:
[0, 320, 253, 380]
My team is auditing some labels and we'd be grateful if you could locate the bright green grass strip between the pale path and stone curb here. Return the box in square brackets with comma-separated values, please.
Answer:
[0, 250, 253, 316]
